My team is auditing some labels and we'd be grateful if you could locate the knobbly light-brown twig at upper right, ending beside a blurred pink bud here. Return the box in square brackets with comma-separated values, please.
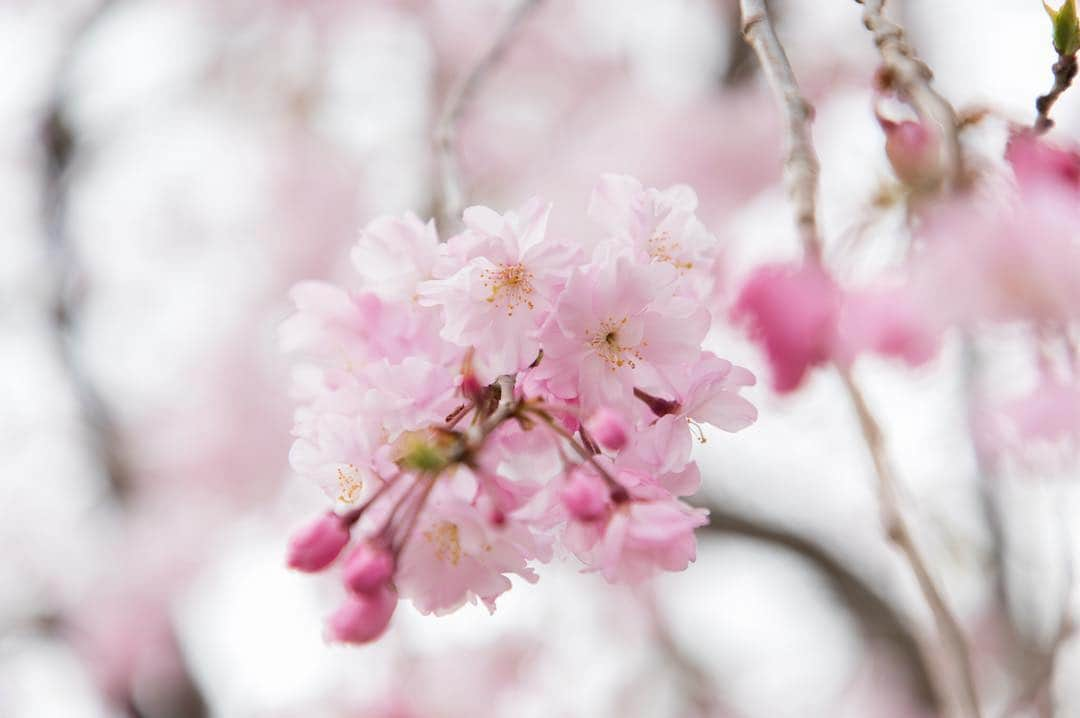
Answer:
[855, 0, 968, 189]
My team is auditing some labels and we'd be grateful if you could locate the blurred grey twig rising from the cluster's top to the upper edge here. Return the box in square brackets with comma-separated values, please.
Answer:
[434, 0, 541, 235]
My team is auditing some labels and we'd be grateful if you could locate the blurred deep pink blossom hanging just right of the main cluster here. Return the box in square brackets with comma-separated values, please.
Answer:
[733, 262, 840, 393]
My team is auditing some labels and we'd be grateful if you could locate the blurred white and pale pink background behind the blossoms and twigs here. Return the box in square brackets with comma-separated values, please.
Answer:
[0, 0, 1080, 718]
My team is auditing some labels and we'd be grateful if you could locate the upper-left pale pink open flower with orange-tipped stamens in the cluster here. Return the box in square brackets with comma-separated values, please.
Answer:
[419, 200, 573, 381]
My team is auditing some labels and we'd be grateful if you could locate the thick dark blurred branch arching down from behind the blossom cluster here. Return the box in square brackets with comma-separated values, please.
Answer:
[705, 504, 941, 713]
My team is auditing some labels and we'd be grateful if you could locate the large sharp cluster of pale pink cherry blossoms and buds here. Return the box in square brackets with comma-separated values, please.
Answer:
[282, 175, 756, 642]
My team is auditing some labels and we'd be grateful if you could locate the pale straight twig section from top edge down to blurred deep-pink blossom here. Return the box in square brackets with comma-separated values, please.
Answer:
[740, 0, 822, 259]
